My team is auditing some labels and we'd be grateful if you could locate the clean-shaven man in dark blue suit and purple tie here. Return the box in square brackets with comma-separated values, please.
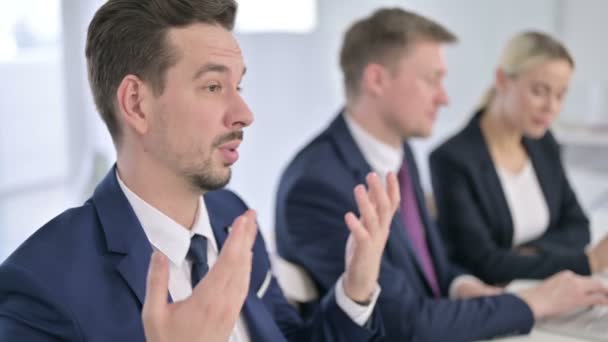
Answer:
[276, 9, 606, 341]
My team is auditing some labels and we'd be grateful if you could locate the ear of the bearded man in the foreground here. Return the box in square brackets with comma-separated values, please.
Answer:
[116, 75, 153, 134]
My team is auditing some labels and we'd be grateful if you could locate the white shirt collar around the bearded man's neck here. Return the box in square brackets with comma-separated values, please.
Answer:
[116, 172, 217, 266]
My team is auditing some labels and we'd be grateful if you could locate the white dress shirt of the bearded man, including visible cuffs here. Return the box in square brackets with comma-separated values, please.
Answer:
[116, 172, 380, 342]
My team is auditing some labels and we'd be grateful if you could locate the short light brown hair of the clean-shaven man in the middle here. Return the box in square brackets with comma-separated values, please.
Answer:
[340, 8, 457, 98]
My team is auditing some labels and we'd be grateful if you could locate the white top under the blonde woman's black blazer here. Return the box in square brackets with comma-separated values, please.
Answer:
[497, 159, 549, 246]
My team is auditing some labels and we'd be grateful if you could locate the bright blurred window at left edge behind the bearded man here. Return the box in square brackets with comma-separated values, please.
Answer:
[0, 0, 68, 261]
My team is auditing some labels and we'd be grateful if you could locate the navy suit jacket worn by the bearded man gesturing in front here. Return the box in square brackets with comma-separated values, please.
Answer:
[0, 169, 382, 342]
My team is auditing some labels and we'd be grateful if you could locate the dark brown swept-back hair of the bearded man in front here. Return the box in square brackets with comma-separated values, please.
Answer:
[85, 0, 237, 145]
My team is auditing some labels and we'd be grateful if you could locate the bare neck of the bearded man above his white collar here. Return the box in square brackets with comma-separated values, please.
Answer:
[117, 154, 202, 229]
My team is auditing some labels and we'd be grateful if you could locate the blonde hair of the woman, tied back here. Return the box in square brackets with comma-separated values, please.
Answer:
[478, 31, 574, 109]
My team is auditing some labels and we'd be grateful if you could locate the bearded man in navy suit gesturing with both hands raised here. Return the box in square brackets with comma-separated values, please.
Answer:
[0, 0, 399, 342]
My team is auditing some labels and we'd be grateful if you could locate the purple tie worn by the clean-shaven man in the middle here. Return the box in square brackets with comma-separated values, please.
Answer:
[399, 160, 441, 298]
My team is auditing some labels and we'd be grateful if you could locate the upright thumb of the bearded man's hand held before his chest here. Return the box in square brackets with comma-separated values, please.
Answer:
[142, 251, 169, 321]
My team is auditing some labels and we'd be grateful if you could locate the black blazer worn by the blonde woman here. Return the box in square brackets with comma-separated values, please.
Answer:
[430, 112, 590, 283]
